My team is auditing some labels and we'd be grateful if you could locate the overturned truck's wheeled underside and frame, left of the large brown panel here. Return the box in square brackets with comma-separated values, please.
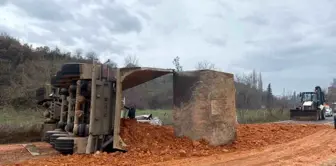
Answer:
[39, 63, 173, 154]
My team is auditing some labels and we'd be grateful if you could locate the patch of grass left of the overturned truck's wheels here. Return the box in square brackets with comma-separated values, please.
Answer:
[0, 107, 43, 144]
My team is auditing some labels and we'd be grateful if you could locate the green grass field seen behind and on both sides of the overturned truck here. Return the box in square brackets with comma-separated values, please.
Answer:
[0, 107, 289, 144]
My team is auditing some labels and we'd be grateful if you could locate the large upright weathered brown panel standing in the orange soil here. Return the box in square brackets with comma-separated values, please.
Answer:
[173, 70, 237, 145]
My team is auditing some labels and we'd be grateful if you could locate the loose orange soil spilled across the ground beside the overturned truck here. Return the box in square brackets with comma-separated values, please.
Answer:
[11, 120, 330, 166]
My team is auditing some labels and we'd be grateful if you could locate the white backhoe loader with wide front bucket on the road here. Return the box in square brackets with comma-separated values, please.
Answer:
[290, 86, 326, 121]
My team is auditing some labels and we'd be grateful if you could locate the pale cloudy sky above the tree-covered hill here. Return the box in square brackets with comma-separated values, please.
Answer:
[0, 0, 336, 94]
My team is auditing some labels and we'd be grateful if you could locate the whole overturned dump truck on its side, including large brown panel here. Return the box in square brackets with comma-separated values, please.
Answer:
[37, 63, 236, 154]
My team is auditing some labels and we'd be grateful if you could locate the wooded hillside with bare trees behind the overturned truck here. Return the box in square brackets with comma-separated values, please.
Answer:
[0, 34, 287, 109]
